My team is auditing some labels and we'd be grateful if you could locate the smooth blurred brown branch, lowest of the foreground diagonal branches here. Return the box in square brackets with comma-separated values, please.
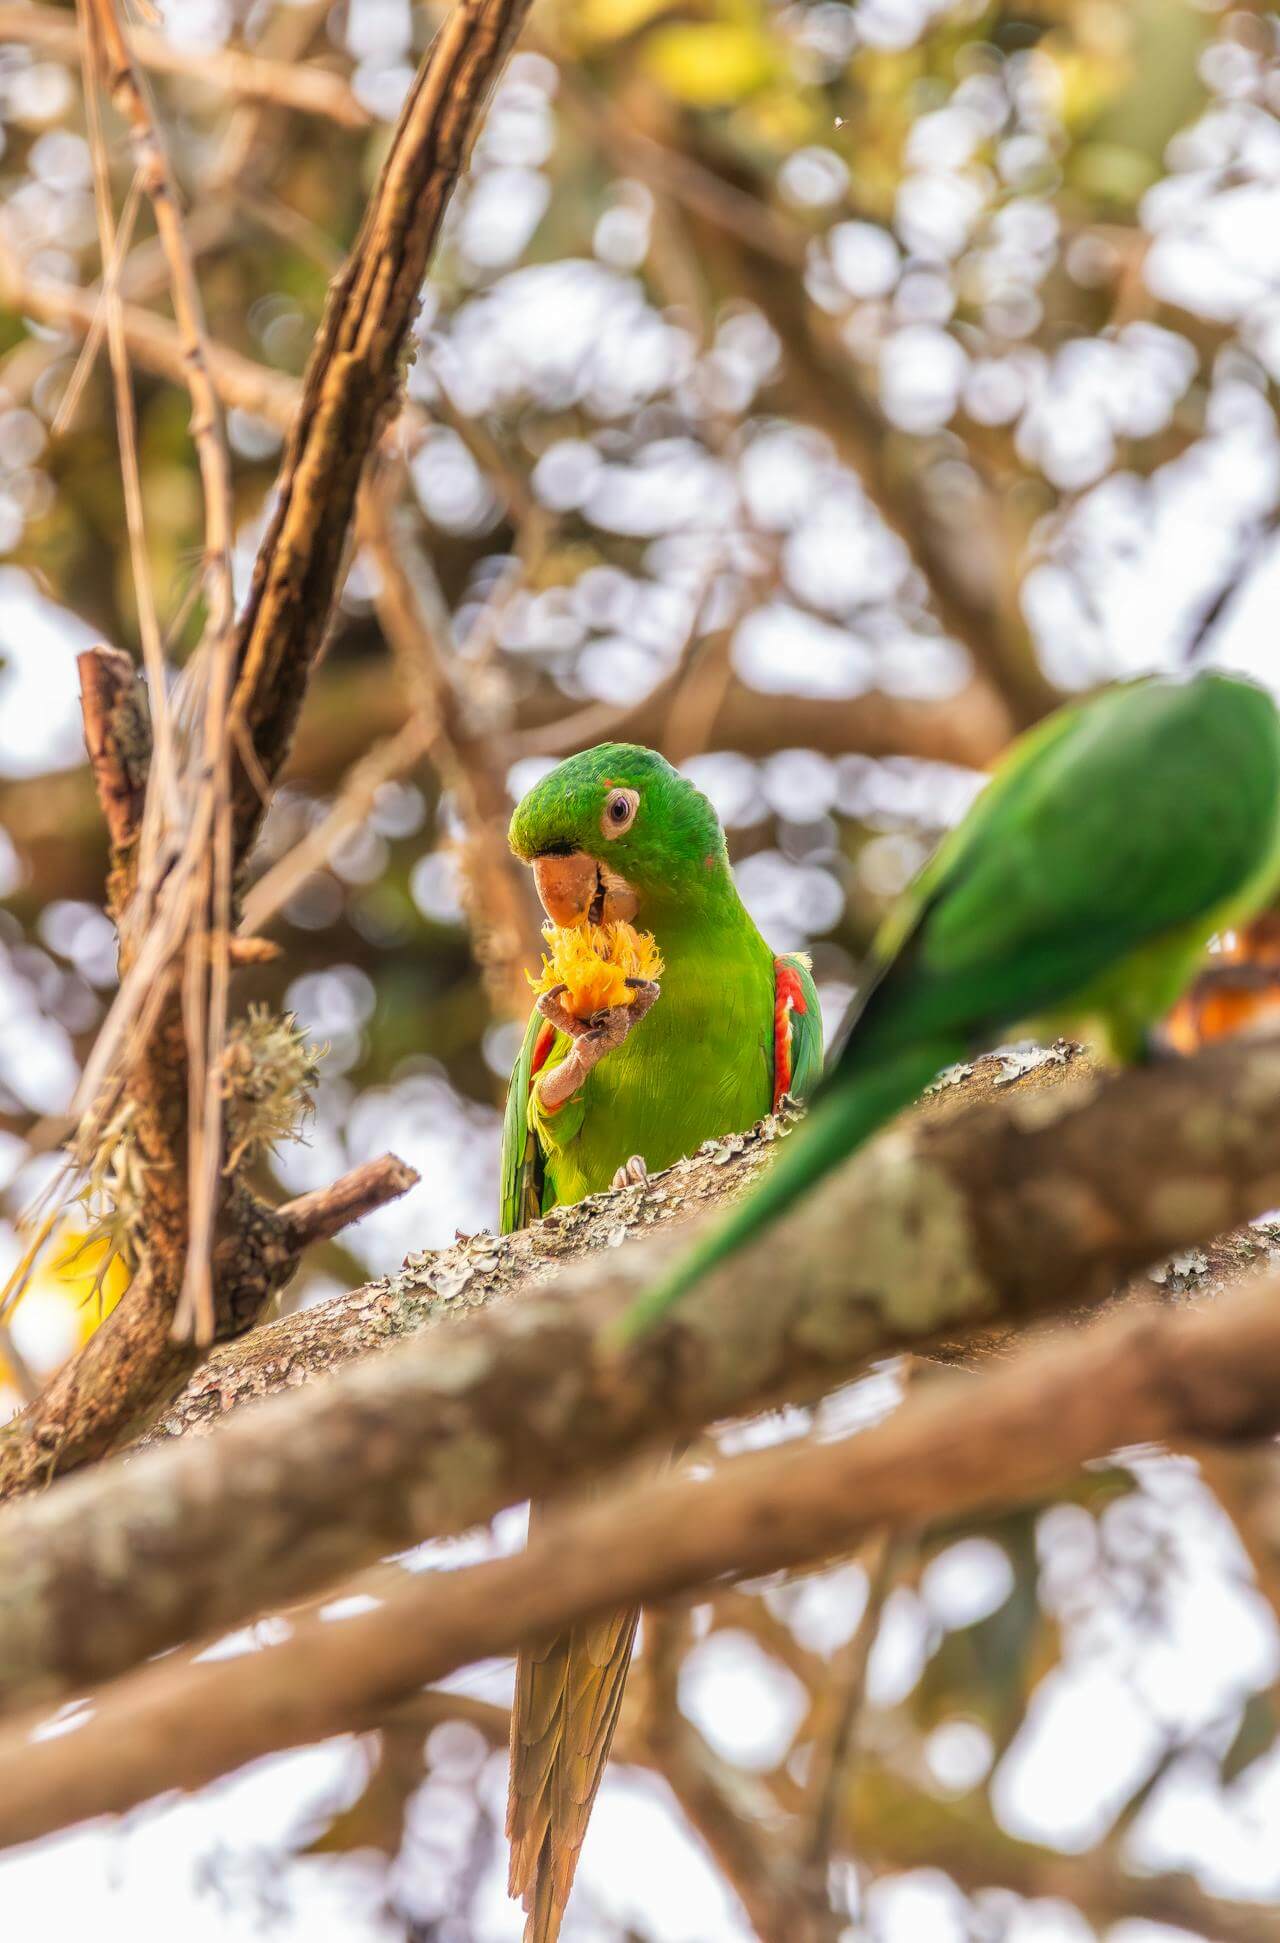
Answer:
[0, 1284, 1280, 1842]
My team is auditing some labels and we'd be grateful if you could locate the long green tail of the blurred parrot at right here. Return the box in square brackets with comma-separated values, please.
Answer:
[610, 1041, 963, 1348]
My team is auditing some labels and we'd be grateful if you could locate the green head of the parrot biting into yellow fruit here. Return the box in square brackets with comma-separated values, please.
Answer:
[511, 742, 730, 929]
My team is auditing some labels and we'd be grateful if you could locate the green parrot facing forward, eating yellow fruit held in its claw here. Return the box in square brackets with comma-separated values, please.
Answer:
[501, 742, 822, 1943]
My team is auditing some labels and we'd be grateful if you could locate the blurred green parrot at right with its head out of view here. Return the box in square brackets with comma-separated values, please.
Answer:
[616, 674, 1280, 1343]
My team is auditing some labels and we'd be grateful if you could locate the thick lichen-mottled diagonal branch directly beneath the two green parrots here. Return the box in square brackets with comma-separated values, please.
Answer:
[0, 1040, 1280, 1704]
